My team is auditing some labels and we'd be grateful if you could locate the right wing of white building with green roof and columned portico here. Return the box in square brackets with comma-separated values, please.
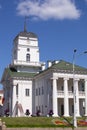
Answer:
[35, 61, 87, 117]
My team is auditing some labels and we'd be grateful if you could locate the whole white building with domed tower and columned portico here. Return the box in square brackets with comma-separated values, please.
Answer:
[1, 29, 87, 116]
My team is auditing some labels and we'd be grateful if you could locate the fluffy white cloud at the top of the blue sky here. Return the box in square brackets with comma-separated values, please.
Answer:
[17, 0, 81, 20]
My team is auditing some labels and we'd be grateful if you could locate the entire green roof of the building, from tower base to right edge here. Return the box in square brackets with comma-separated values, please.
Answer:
[4, 60, 87, 78]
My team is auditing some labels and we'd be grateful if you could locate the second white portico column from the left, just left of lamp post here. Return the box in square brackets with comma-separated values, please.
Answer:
[64, 78, 69, 116]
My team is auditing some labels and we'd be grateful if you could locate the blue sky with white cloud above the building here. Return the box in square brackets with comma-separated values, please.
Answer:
[0, 0, 87, 89]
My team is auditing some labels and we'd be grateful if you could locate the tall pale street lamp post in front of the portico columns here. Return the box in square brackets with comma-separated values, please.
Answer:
[73, 49, 87, 127]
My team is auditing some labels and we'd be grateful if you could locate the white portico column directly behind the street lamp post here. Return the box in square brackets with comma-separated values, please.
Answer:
[74, 79, 80, 117]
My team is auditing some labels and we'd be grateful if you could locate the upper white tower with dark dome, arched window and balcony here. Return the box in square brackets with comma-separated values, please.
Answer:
[11, 29, 44, 73]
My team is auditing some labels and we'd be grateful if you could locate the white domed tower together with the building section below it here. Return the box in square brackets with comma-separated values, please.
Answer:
[2, 24, 45, 117]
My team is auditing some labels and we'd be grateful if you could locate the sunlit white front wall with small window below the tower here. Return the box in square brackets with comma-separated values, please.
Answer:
[13, 80, 32, 114]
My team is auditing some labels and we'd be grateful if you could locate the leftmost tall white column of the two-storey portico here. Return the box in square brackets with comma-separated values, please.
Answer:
[53, 79, 58, 117]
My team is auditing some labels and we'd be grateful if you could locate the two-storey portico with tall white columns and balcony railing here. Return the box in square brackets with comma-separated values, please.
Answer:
[52, 77, 87, 117]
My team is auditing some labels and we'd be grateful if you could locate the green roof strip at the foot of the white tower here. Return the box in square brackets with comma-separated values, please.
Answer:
[6, 68, 36, 78]
